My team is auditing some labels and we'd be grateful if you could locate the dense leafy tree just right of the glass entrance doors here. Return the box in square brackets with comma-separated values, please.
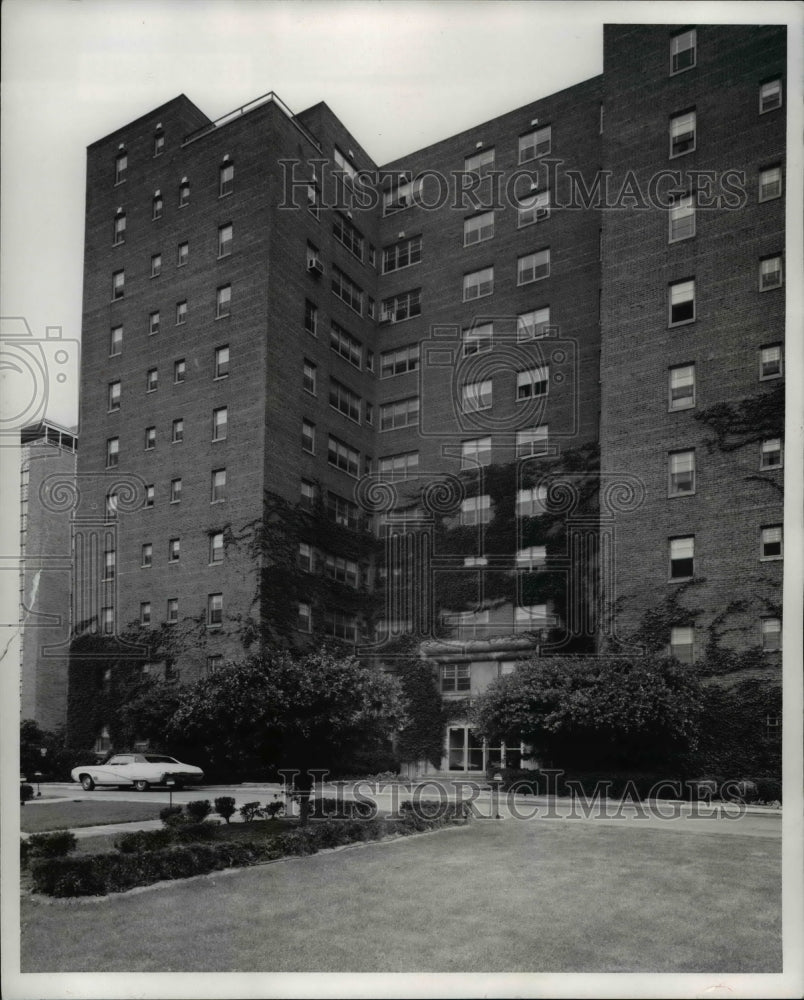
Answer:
[475, 657, 700, 770]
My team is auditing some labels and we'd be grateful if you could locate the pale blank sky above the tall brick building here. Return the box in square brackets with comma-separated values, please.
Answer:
[0, 0, 796, 426]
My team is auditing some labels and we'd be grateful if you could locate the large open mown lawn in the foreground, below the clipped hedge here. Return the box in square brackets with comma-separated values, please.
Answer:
[22, 819, 781, 974]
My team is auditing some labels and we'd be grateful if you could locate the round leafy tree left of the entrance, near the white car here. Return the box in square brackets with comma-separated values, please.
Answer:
[168, 648, 405, 788]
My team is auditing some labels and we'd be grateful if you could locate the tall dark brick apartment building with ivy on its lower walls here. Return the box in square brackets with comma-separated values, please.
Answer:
[74, 25, 785, 771]
